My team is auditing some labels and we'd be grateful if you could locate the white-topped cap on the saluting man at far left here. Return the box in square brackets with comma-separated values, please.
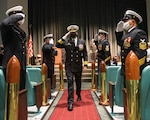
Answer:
[6, 6, 23, 16]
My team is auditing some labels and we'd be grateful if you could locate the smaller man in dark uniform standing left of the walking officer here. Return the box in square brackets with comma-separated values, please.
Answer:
[41, 34, 57, 88]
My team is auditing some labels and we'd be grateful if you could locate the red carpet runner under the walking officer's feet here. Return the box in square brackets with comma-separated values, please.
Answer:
[49, 90, 100, 120]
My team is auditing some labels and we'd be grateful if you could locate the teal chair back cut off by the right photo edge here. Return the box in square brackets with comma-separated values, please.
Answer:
[140, 65, 150, 120]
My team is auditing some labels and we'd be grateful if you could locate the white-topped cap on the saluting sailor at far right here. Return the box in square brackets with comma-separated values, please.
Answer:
[123, 10, 143, 23]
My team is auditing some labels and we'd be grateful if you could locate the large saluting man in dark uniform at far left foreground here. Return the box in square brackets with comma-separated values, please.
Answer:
[0, 6, 26, 90]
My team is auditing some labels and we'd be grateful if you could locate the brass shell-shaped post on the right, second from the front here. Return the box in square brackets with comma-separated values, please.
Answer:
[99, 61, 109, 106]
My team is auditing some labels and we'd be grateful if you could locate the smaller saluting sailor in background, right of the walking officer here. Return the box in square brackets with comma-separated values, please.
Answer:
[94, 29, 111, 65]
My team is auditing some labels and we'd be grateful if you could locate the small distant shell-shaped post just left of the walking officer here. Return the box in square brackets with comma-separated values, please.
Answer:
[59, 63, 64, 90]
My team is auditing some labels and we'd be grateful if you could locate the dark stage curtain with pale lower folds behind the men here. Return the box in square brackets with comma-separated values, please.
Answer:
[28, 0, 147, 55]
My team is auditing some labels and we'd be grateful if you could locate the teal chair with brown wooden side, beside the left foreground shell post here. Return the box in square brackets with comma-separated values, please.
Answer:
[26, 69, 43, 111]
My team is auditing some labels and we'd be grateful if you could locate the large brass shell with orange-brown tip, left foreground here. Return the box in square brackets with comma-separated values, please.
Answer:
[4, 55, 20, 120]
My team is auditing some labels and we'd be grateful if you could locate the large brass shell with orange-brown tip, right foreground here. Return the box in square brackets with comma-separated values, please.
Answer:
[125, 51, 141, 120]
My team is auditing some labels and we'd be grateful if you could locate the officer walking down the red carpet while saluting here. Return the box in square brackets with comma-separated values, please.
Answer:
[56, 25, 88, 111]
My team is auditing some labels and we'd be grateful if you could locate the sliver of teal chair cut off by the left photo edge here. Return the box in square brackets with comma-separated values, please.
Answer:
[0, 69, 6, 120]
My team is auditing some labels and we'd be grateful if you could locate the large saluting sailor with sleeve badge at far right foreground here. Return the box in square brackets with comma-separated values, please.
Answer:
[115, 10, 148, 86]
